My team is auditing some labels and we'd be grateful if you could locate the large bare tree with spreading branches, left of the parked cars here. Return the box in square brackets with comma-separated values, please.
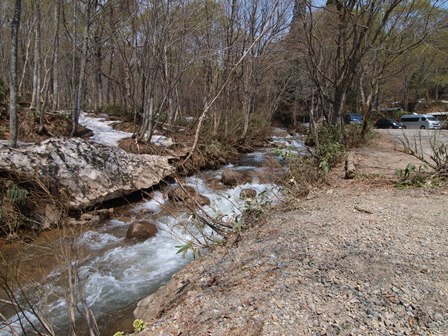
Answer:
[297, 0, 412, 129]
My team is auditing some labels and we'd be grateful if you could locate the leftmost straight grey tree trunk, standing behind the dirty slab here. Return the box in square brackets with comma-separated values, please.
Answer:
[9, 0, 22, 147]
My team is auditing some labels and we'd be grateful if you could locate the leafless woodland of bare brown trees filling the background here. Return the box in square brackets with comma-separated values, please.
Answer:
[0, 0, 448, 150]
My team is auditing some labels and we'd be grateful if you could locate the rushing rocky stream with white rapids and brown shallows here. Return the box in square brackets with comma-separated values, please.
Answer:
[0, 115, 304, 335]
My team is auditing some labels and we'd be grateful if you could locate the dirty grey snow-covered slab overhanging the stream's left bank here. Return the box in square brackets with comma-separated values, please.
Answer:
[0, 138, 174, 209]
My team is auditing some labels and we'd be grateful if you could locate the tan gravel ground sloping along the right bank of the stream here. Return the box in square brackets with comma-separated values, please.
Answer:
[136, 132, 448, 335]
